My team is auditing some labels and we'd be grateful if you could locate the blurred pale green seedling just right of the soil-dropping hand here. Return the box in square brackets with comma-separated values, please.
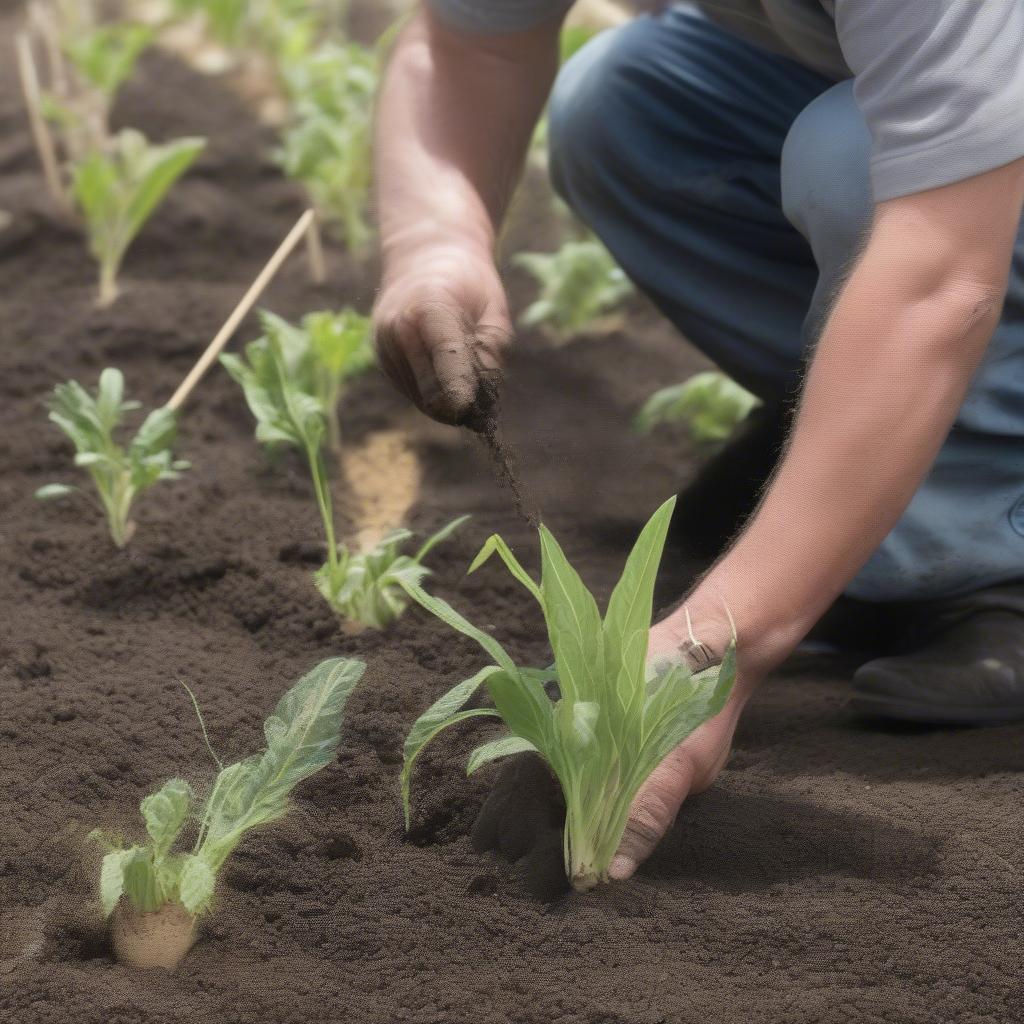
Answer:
[512, 239, 633, 341]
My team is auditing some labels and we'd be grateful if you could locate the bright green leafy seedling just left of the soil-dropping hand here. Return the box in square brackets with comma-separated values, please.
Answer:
[252, 308, 374, 453]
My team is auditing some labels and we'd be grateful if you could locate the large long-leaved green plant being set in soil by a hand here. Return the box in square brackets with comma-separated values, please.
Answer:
[400, 499, 736, 890]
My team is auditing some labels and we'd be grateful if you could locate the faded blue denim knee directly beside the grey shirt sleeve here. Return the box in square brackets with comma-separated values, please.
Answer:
[781, 82, 873, 268]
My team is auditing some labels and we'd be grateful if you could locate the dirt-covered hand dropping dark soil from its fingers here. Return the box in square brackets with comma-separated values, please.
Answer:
[374, 244, 512, 426]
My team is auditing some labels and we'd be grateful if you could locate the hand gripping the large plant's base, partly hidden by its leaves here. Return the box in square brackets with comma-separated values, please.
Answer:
[609, 609, 762, 879]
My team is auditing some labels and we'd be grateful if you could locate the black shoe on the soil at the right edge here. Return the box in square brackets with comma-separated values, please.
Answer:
[850, 582, 1024, 725]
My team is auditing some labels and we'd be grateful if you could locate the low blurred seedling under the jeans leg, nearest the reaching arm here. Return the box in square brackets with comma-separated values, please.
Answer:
[635, 370, 760, 444]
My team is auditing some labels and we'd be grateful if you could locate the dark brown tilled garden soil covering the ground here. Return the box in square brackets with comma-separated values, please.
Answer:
[0, 5, 1024, 1024]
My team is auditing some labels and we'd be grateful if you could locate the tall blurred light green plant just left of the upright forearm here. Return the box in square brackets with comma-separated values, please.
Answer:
[276, 43, 379, 252]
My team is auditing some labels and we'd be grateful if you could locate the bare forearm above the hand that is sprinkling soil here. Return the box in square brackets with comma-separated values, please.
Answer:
[376, 10, 558, 270]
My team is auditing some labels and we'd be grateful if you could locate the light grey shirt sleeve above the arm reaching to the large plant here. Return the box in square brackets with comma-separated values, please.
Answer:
[836, 0, 1024, 202]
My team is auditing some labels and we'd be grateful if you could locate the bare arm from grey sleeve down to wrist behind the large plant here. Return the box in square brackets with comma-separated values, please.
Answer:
[667, 163, 1024, 677]
